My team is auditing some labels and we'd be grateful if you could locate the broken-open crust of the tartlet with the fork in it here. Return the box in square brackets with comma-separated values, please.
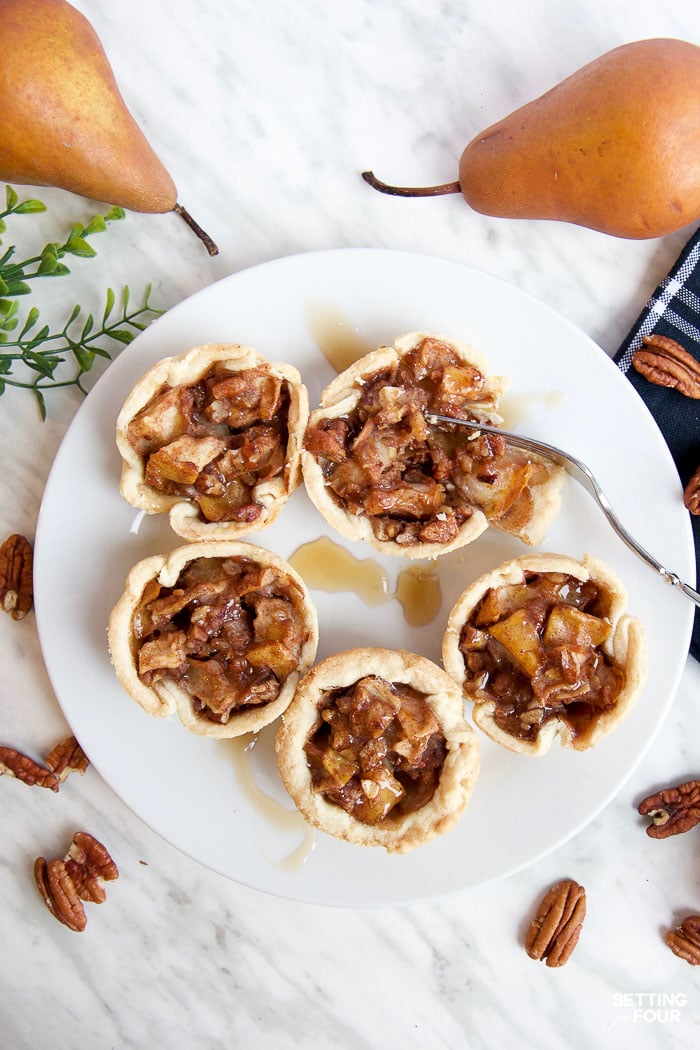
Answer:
[301, 332, 566, 559]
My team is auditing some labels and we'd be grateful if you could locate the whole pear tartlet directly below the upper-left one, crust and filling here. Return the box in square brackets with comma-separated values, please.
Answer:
[108, 541, 318, 737]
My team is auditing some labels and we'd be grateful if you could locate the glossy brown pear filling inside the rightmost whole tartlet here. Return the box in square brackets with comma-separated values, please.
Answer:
[460, 572, 624, 741]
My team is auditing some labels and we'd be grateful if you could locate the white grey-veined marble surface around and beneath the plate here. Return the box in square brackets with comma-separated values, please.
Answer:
[0, 0, 700, 1050]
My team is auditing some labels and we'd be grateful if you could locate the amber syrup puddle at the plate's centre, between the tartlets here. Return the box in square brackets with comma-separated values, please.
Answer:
[289, 536, 391, 605]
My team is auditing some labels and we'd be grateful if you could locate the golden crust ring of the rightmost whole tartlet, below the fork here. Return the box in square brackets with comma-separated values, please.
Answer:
[442, 553, 646, 755]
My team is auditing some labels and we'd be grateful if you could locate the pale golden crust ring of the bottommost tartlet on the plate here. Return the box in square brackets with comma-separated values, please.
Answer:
[275, 648, 480, 854]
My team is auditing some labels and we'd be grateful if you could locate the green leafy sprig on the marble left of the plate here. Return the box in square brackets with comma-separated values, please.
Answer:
[0, 186, 163, 419]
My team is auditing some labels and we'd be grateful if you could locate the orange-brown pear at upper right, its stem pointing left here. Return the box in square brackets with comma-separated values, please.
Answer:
[363, 39, 700, 238]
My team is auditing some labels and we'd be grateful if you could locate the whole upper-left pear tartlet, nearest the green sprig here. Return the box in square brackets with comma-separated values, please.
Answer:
[116, 343, 309, 541]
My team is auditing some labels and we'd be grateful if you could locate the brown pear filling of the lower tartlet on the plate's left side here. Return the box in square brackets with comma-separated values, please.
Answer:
[132, 558, 306, 723]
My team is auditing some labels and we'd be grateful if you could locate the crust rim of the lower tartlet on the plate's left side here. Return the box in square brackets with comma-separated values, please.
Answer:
[108, 541, 318, 737]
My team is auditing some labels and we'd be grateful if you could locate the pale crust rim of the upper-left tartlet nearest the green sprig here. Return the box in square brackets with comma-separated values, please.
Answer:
[116, 343, 309, 541]
